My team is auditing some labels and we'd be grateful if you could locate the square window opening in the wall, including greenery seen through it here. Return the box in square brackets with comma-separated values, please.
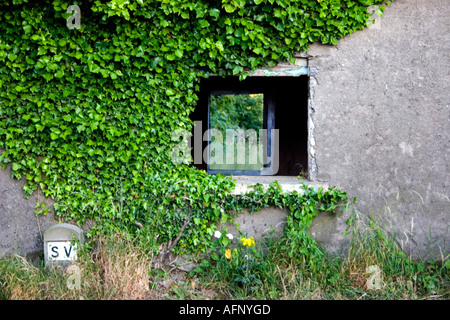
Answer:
[191, 76, 308, 177]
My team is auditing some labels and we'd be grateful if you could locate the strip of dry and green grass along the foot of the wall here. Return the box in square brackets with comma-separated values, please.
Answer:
[0, 215, 450, 300]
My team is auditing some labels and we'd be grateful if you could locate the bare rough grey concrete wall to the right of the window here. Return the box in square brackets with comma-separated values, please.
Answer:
[308, 0, 450, 259]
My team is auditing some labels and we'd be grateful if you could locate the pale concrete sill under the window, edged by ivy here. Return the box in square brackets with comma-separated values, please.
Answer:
[232, 176, 328, 194]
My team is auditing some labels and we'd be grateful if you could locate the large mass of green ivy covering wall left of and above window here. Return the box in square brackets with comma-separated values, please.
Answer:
[0, 0, 382, 251]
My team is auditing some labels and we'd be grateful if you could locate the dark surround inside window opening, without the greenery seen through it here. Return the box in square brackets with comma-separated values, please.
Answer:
[189, 75, 310, 178]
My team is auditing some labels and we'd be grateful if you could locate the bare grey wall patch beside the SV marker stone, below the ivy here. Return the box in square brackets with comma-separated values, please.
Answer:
[0, 161, 56, 261]
